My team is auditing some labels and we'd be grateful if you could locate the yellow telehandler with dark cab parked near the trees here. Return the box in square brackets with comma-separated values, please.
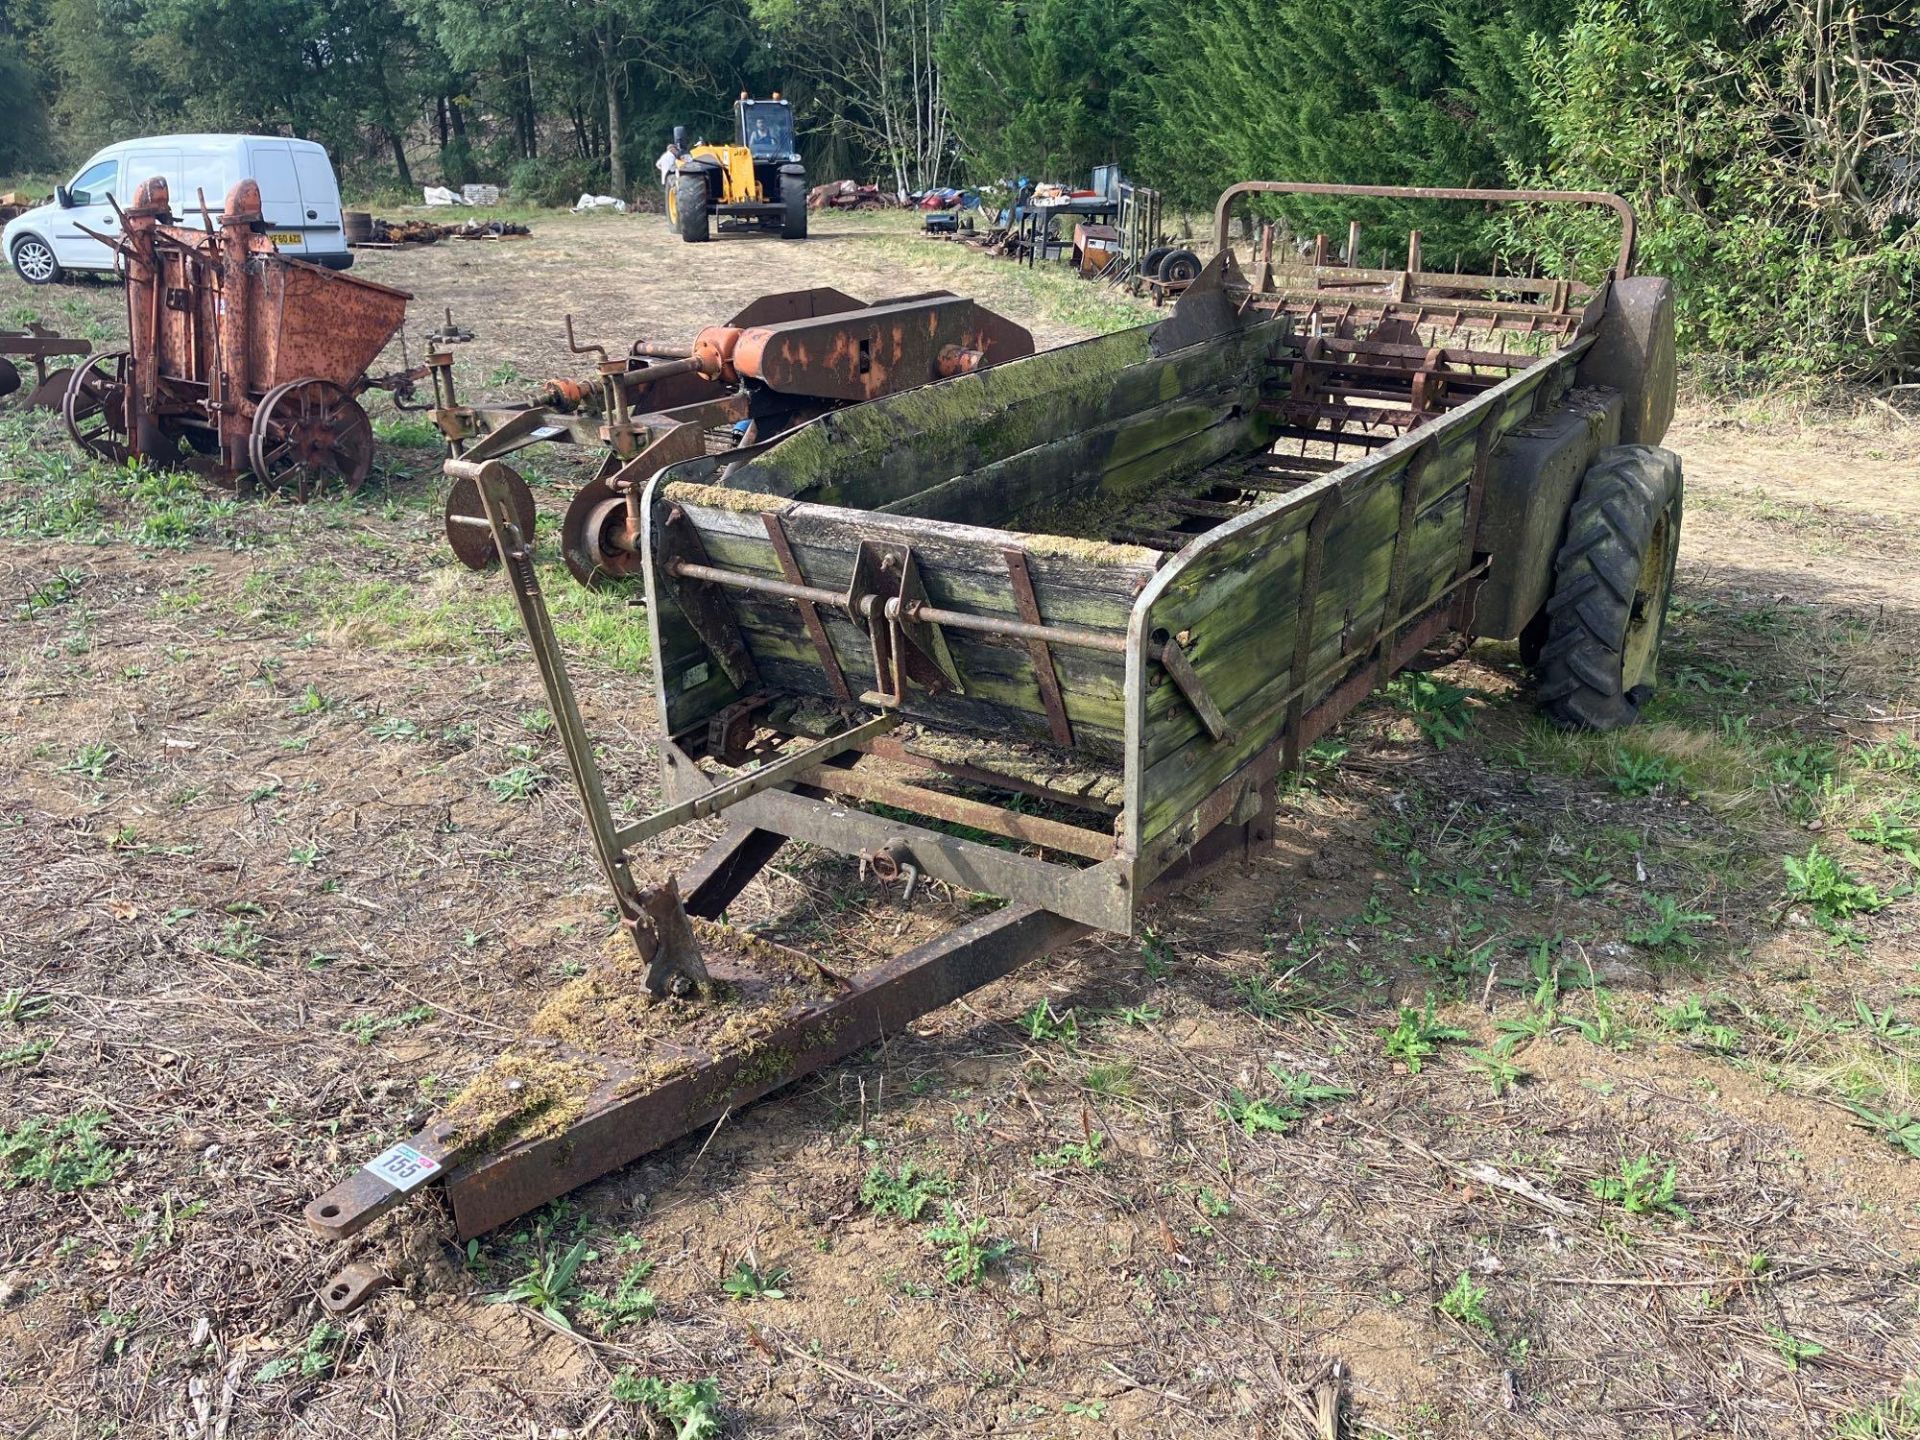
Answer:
[660, 90, 806, 242]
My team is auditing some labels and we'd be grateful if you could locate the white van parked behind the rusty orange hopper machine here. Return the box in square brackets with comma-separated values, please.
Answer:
[0, 134, 353, 284]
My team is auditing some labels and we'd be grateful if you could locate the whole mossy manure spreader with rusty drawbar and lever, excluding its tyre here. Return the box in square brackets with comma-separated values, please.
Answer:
[307, 182, 1678, 1282]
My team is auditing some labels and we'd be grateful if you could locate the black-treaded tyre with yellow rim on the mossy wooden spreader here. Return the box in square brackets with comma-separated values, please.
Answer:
[1540, 445, 1684, 730]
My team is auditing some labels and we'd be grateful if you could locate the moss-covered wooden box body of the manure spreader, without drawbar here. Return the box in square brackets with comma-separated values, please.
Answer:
[645, 183, 1672, 931]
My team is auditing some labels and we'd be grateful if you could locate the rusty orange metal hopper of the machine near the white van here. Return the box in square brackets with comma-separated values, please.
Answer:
[246, 255, 407, 394]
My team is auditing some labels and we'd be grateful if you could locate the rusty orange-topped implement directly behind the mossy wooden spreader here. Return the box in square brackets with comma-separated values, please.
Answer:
[426, 288, 1033, 586]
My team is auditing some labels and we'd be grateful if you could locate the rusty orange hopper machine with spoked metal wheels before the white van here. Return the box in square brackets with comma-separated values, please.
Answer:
[61, 177, 424, 499]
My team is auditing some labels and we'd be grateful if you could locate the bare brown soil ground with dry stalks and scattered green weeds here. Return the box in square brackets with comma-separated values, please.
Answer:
[0, 217, 1920, 1440]
